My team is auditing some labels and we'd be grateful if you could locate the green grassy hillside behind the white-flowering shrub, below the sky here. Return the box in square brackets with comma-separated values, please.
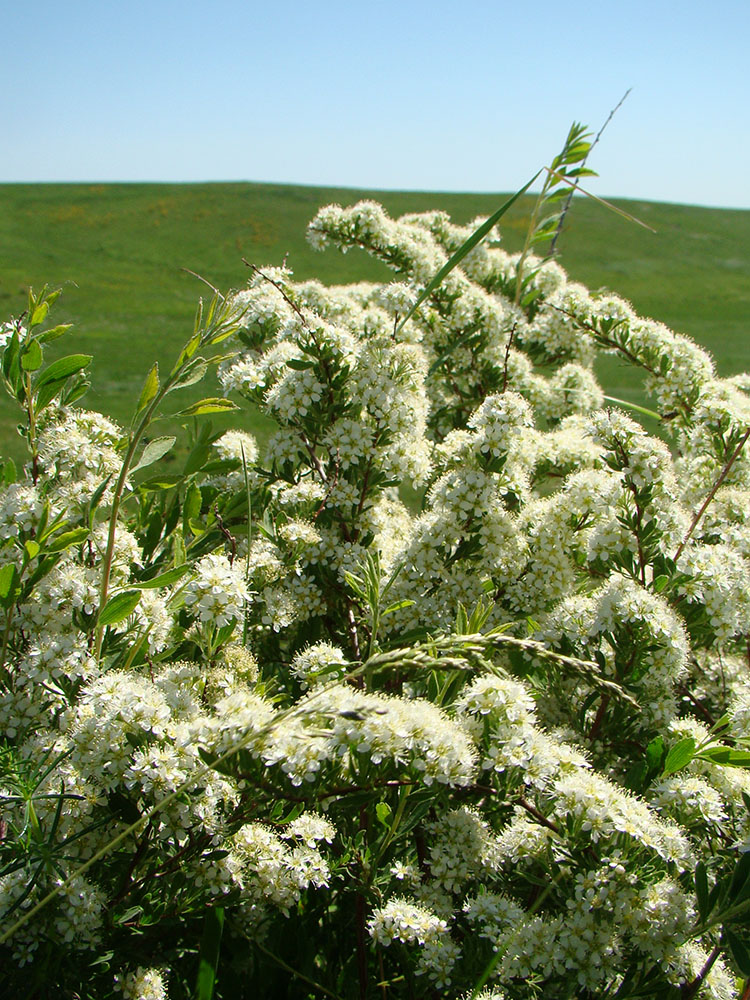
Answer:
[0, 183, 750, 457]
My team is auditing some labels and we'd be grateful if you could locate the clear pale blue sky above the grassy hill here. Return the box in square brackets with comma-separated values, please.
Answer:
[5, 0, 750, 208]
